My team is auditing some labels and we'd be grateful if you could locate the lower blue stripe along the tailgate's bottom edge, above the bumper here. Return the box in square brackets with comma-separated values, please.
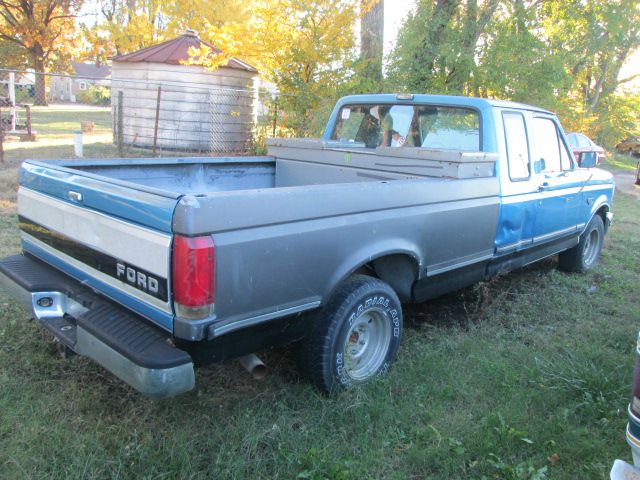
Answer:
[22, 239, 173, 332]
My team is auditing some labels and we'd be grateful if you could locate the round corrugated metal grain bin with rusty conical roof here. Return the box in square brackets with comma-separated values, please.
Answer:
[111, 31, 257, 153]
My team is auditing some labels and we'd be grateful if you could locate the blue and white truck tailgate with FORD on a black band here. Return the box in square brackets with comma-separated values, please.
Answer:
[18, 162, 178, 331]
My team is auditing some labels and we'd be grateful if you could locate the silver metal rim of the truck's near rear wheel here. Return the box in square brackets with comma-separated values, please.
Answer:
[344, 308, 392, 381]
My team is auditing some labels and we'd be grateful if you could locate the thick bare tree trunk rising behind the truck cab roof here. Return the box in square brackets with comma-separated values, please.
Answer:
[360, 0, 384, 83]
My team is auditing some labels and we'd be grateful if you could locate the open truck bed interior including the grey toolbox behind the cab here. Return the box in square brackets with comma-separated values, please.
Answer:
[52, 139, 495, 196]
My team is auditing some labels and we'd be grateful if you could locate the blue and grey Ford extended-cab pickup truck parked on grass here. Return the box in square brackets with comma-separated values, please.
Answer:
[0, 94, 614, 397]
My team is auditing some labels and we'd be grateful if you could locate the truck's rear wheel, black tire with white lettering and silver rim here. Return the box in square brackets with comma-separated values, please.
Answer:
[298, 275, 402, 393]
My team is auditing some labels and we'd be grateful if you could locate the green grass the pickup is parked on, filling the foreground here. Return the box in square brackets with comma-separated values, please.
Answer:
[0, 109, 640, 480]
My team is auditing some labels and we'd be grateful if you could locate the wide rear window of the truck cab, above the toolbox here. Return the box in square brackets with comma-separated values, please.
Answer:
[331, 104, 480, 151]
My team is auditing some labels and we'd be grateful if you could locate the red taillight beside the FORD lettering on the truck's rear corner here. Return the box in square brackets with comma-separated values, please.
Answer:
[173, 235, 215, 320]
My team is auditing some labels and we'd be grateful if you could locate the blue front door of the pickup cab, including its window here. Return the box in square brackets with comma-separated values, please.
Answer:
[532, 115, 584, 245]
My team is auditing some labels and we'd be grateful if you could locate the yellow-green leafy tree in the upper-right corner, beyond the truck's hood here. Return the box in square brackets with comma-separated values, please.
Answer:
[541, 0, 640, 145]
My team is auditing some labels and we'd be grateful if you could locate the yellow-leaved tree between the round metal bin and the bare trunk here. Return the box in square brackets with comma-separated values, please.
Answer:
[191, 0, 357, 135]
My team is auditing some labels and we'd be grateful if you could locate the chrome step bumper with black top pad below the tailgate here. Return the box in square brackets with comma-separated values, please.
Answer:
[0, 255, 195, 398]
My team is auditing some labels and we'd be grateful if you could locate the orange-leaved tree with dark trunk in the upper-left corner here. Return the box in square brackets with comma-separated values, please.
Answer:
[0, 0, 82, 105]
